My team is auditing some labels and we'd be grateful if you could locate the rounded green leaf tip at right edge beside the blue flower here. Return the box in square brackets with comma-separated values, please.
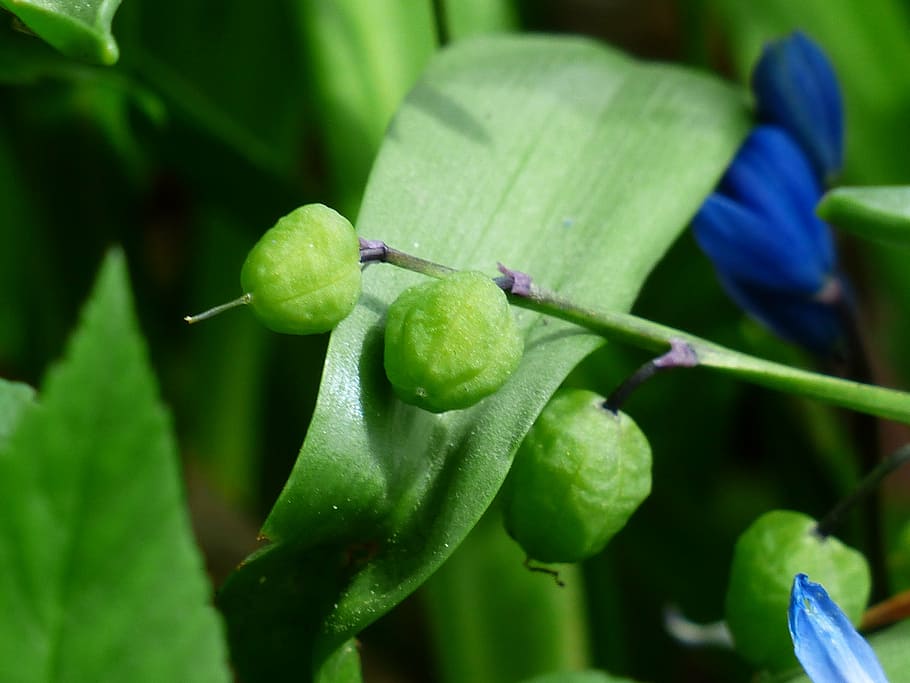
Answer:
[817, 185, 910, 246]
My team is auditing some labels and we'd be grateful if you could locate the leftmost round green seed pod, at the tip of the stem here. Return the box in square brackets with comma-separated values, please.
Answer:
[240, 204, 361, 334]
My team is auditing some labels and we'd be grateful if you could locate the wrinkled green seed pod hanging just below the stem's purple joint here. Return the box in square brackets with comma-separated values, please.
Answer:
[502, 389, 651, 562]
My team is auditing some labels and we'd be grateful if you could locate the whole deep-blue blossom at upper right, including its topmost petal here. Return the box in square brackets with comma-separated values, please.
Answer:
[693, 33, 849, 354]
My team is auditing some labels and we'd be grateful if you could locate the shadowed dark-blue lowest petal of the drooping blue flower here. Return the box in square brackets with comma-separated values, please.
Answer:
[718, 273, 844, 356]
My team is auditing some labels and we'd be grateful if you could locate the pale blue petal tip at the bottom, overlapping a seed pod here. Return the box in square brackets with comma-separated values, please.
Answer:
[788, 574, 888, 683]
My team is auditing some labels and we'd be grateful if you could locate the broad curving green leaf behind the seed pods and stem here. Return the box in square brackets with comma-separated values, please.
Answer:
[220, 37, 749, 676]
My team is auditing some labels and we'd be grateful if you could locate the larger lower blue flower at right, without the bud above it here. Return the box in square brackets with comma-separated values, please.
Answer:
[692, 125, 844, 354]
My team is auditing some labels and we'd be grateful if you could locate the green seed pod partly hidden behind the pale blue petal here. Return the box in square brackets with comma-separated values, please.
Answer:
[726, 510, 870, 671]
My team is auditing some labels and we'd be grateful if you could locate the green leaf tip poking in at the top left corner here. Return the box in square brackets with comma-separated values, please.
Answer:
[0, 0, 120, 65]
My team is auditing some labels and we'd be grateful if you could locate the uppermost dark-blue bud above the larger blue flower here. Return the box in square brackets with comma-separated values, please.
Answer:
[752, 31, 844, 182]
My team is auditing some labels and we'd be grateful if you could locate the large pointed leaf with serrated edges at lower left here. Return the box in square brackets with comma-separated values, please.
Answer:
[0, 252, 230, 682]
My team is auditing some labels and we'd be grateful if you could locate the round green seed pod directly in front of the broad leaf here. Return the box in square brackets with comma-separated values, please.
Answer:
[385, 272, 524, 413]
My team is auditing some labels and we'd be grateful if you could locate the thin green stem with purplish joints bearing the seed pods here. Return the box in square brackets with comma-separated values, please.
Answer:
[361, 240, 910, 424]
